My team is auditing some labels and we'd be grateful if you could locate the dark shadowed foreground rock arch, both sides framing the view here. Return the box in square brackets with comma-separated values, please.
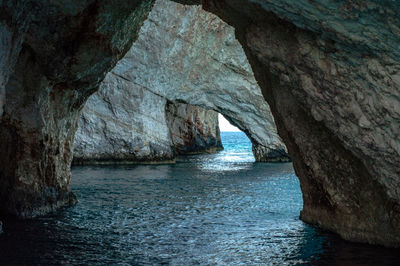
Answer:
[0, 0, 400, 246]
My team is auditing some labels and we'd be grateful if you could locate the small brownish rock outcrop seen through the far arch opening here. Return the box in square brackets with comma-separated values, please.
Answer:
[166, 102, 223, 154]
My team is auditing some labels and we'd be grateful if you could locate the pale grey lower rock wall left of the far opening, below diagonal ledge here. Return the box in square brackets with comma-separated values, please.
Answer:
[74, 74, 175, 164]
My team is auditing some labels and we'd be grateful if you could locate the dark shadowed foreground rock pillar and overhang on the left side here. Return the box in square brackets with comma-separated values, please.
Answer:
[0, 0, 152, 217]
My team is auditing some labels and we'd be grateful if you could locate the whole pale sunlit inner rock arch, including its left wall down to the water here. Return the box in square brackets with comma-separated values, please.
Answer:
[74, 1, 287, 163]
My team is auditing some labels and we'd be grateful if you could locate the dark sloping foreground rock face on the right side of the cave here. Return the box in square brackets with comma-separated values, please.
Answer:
[196, 0, 400, 246]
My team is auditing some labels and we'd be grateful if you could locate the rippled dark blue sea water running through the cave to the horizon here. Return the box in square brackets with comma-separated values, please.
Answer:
[0, 133, 400, 265]
